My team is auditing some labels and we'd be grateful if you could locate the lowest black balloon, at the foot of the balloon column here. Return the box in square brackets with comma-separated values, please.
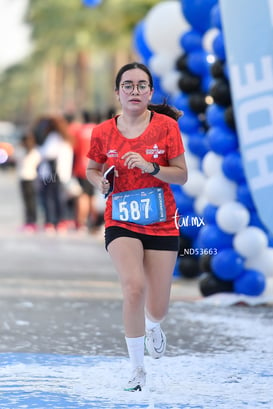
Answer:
[199, 273, 234, 297]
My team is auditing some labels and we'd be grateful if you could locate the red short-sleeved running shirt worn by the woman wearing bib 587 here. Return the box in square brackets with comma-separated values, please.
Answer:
[87, 112, 184, 236]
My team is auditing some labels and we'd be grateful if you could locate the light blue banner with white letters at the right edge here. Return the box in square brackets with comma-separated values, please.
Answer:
[220, 0, 273, 233]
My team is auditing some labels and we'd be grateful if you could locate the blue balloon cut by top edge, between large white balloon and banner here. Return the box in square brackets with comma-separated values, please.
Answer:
[181, 0, 218, 33]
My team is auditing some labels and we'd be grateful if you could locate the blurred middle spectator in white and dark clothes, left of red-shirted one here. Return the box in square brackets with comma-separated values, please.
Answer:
[37, 116, 73, 232]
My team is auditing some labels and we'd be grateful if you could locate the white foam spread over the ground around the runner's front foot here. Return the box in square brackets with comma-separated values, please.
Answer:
[0, 303, 273, 409]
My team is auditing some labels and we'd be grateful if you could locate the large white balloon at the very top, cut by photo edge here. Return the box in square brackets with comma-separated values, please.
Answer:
[144, 1, 190, 55]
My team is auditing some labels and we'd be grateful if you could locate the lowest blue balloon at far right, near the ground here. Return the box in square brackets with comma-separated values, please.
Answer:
[234, 269, 266, 296]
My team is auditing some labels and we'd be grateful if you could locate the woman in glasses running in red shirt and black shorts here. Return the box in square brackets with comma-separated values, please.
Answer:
[86, 63, 187, 391]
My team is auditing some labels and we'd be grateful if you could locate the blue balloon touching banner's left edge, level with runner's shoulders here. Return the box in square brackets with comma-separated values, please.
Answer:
[207, 126, 238, 155]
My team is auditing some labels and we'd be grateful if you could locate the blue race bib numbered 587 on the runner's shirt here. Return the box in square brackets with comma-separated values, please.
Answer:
[112, 187, 166, 225]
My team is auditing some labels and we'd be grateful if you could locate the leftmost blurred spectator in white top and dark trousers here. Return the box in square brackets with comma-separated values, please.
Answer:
[15, 133, 41, 232]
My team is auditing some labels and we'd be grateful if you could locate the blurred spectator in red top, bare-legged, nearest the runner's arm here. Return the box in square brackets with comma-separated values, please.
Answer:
[73, 111, 103, 231]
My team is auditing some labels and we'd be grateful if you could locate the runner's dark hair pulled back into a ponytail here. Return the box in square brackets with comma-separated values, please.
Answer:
[115, 61, 183, 121]
